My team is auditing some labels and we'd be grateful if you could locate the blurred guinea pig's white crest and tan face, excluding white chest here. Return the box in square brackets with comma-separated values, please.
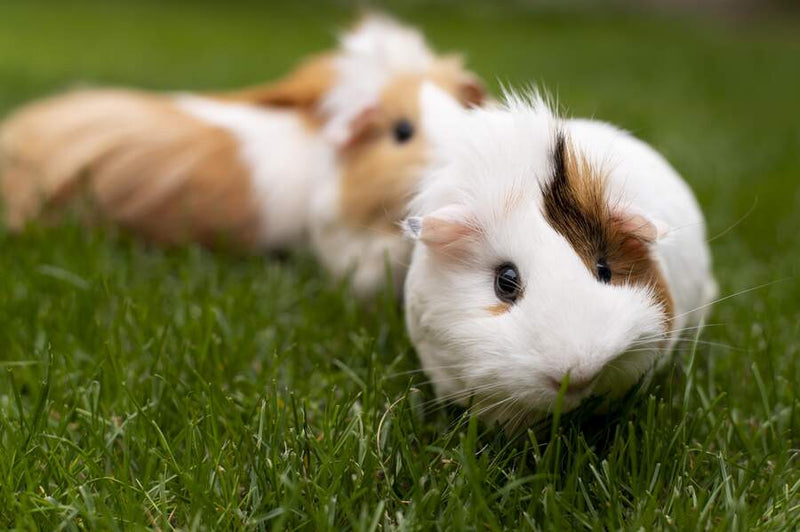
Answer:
[321, 14, 485, 232]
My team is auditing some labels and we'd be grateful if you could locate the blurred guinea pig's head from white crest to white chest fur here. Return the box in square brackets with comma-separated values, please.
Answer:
[304, 15, 485, 297]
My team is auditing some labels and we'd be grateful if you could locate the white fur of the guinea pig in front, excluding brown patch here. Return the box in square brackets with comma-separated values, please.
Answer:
[405, 86, 715, 424]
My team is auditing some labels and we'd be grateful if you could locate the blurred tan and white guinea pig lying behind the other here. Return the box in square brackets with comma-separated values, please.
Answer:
[0, 15, 484, 292]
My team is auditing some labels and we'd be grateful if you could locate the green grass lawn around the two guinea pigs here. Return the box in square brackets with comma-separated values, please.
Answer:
[0, 2, 800, 530]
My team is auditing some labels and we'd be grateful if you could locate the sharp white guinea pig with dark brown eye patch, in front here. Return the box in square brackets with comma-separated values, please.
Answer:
[404, 85, 716, 429]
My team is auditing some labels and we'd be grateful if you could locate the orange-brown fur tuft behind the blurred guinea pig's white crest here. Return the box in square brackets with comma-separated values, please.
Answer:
[217, 54, 335, 108]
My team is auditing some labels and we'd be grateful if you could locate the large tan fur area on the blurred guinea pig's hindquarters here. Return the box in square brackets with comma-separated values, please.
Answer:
[0, 90, 259, 246]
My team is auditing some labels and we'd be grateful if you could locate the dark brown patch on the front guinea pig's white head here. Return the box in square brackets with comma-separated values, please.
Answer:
[543, 133, 673, 319]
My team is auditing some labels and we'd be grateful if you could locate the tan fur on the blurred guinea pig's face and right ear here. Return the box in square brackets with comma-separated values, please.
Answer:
[341, 63, 485, 233]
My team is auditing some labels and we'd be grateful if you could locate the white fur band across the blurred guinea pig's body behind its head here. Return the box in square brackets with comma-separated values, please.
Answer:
[175, 94, 337, 249]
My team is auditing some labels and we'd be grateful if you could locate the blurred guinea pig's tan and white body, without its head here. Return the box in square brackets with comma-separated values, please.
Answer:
[0, 90, 335, 249]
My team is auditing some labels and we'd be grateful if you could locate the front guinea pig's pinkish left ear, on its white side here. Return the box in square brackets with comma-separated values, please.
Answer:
[402, 205, 480, 255]
